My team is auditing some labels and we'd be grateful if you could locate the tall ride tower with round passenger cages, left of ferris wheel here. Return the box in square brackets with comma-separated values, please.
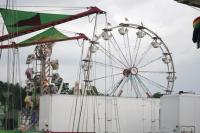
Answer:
[20, 43, 68, 130]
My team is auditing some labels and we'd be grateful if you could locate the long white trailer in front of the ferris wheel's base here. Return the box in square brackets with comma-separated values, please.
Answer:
[39, 95, 160, 133]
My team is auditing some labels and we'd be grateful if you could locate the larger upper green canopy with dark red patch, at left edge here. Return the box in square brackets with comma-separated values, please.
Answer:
[0, 8, 71, 33]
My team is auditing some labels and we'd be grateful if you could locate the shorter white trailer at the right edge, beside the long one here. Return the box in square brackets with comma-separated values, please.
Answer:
[160, 94, 200, 133]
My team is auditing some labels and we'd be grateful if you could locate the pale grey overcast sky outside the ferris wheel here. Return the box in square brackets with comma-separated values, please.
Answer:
[0, 0, 200, 93]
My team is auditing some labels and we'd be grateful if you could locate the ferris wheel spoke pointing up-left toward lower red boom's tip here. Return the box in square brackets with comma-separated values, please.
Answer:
[99, 45, 127, 68]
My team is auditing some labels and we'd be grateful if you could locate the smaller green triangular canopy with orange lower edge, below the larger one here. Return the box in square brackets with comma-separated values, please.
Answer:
[19, 27, 69, 47]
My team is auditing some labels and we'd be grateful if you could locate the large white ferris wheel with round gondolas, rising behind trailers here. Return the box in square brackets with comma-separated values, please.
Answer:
[82, 23, 176, 97]
